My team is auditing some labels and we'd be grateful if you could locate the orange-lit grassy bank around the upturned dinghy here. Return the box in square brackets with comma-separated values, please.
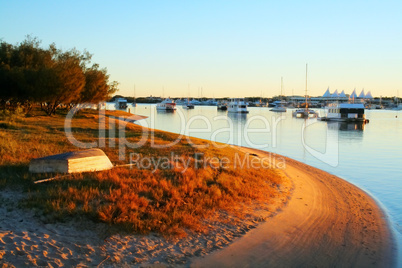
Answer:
[0, 108, 281, 235]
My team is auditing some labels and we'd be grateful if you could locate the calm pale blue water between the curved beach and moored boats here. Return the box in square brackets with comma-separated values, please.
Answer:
[111, 104, 402, 258]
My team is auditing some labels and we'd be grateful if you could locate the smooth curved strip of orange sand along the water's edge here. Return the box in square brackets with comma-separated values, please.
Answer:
[190, 147, 397, 267]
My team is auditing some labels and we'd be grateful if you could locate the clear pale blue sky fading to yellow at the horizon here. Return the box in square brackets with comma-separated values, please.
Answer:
[0, 0, 402, 98]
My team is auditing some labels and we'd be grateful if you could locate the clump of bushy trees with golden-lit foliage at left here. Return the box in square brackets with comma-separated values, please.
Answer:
[0, 36, 117, 115]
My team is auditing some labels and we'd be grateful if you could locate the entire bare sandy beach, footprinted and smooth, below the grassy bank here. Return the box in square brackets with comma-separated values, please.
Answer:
[0, 148, 396, 267]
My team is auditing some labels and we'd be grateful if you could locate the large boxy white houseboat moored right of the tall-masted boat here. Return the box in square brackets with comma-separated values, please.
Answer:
[320, 103, 368, 123]
